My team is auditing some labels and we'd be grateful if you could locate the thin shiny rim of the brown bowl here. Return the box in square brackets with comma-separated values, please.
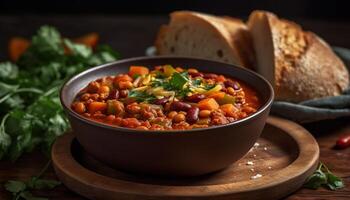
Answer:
[59, 56, 275, 135]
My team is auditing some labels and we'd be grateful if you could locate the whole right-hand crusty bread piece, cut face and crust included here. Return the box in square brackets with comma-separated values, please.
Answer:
[248, 11, 349, 102]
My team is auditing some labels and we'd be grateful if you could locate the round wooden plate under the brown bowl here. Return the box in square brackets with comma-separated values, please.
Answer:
[52, 117, 319, 200]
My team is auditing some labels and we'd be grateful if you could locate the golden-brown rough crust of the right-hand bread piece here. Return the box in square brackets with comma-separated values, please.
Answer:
[253, 11, 349, 102]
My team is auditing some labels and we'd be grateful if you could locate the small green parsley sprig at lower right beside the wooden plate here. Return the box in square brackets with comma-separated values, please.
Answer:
[304, 163, 345, 190]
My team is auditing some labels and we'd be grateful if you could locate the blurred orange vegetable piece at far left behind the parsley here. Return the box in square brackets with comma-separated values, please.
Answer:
[8, 37, 30, 62]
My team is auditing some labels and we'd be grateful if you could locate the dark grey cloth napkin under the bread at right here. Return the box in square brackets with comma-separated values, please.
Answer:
[271, 47, 350, 123]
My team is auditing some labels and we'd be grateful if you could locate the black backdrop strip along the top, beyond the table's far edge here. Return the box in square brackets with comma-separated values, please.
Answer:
[0, 0, 350, 20]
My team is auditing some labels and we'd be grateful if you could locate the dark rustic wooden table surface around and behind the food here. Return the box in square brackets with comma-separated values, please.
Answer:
[0, 15, 350, 200]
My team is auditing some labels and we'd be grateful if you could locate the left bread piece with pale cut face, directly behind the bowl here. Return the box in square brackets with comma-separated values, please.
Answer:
[155, 11, 255, 68]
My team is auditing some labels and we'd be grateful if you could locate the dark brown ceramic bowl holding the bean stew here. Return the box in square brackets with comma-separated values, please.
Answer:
[60, 57, 274, 176]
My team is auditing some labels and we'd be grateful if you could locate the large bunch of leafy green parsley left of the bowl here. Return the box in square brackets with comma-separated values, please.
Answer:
[0, 26, 119, 200]
